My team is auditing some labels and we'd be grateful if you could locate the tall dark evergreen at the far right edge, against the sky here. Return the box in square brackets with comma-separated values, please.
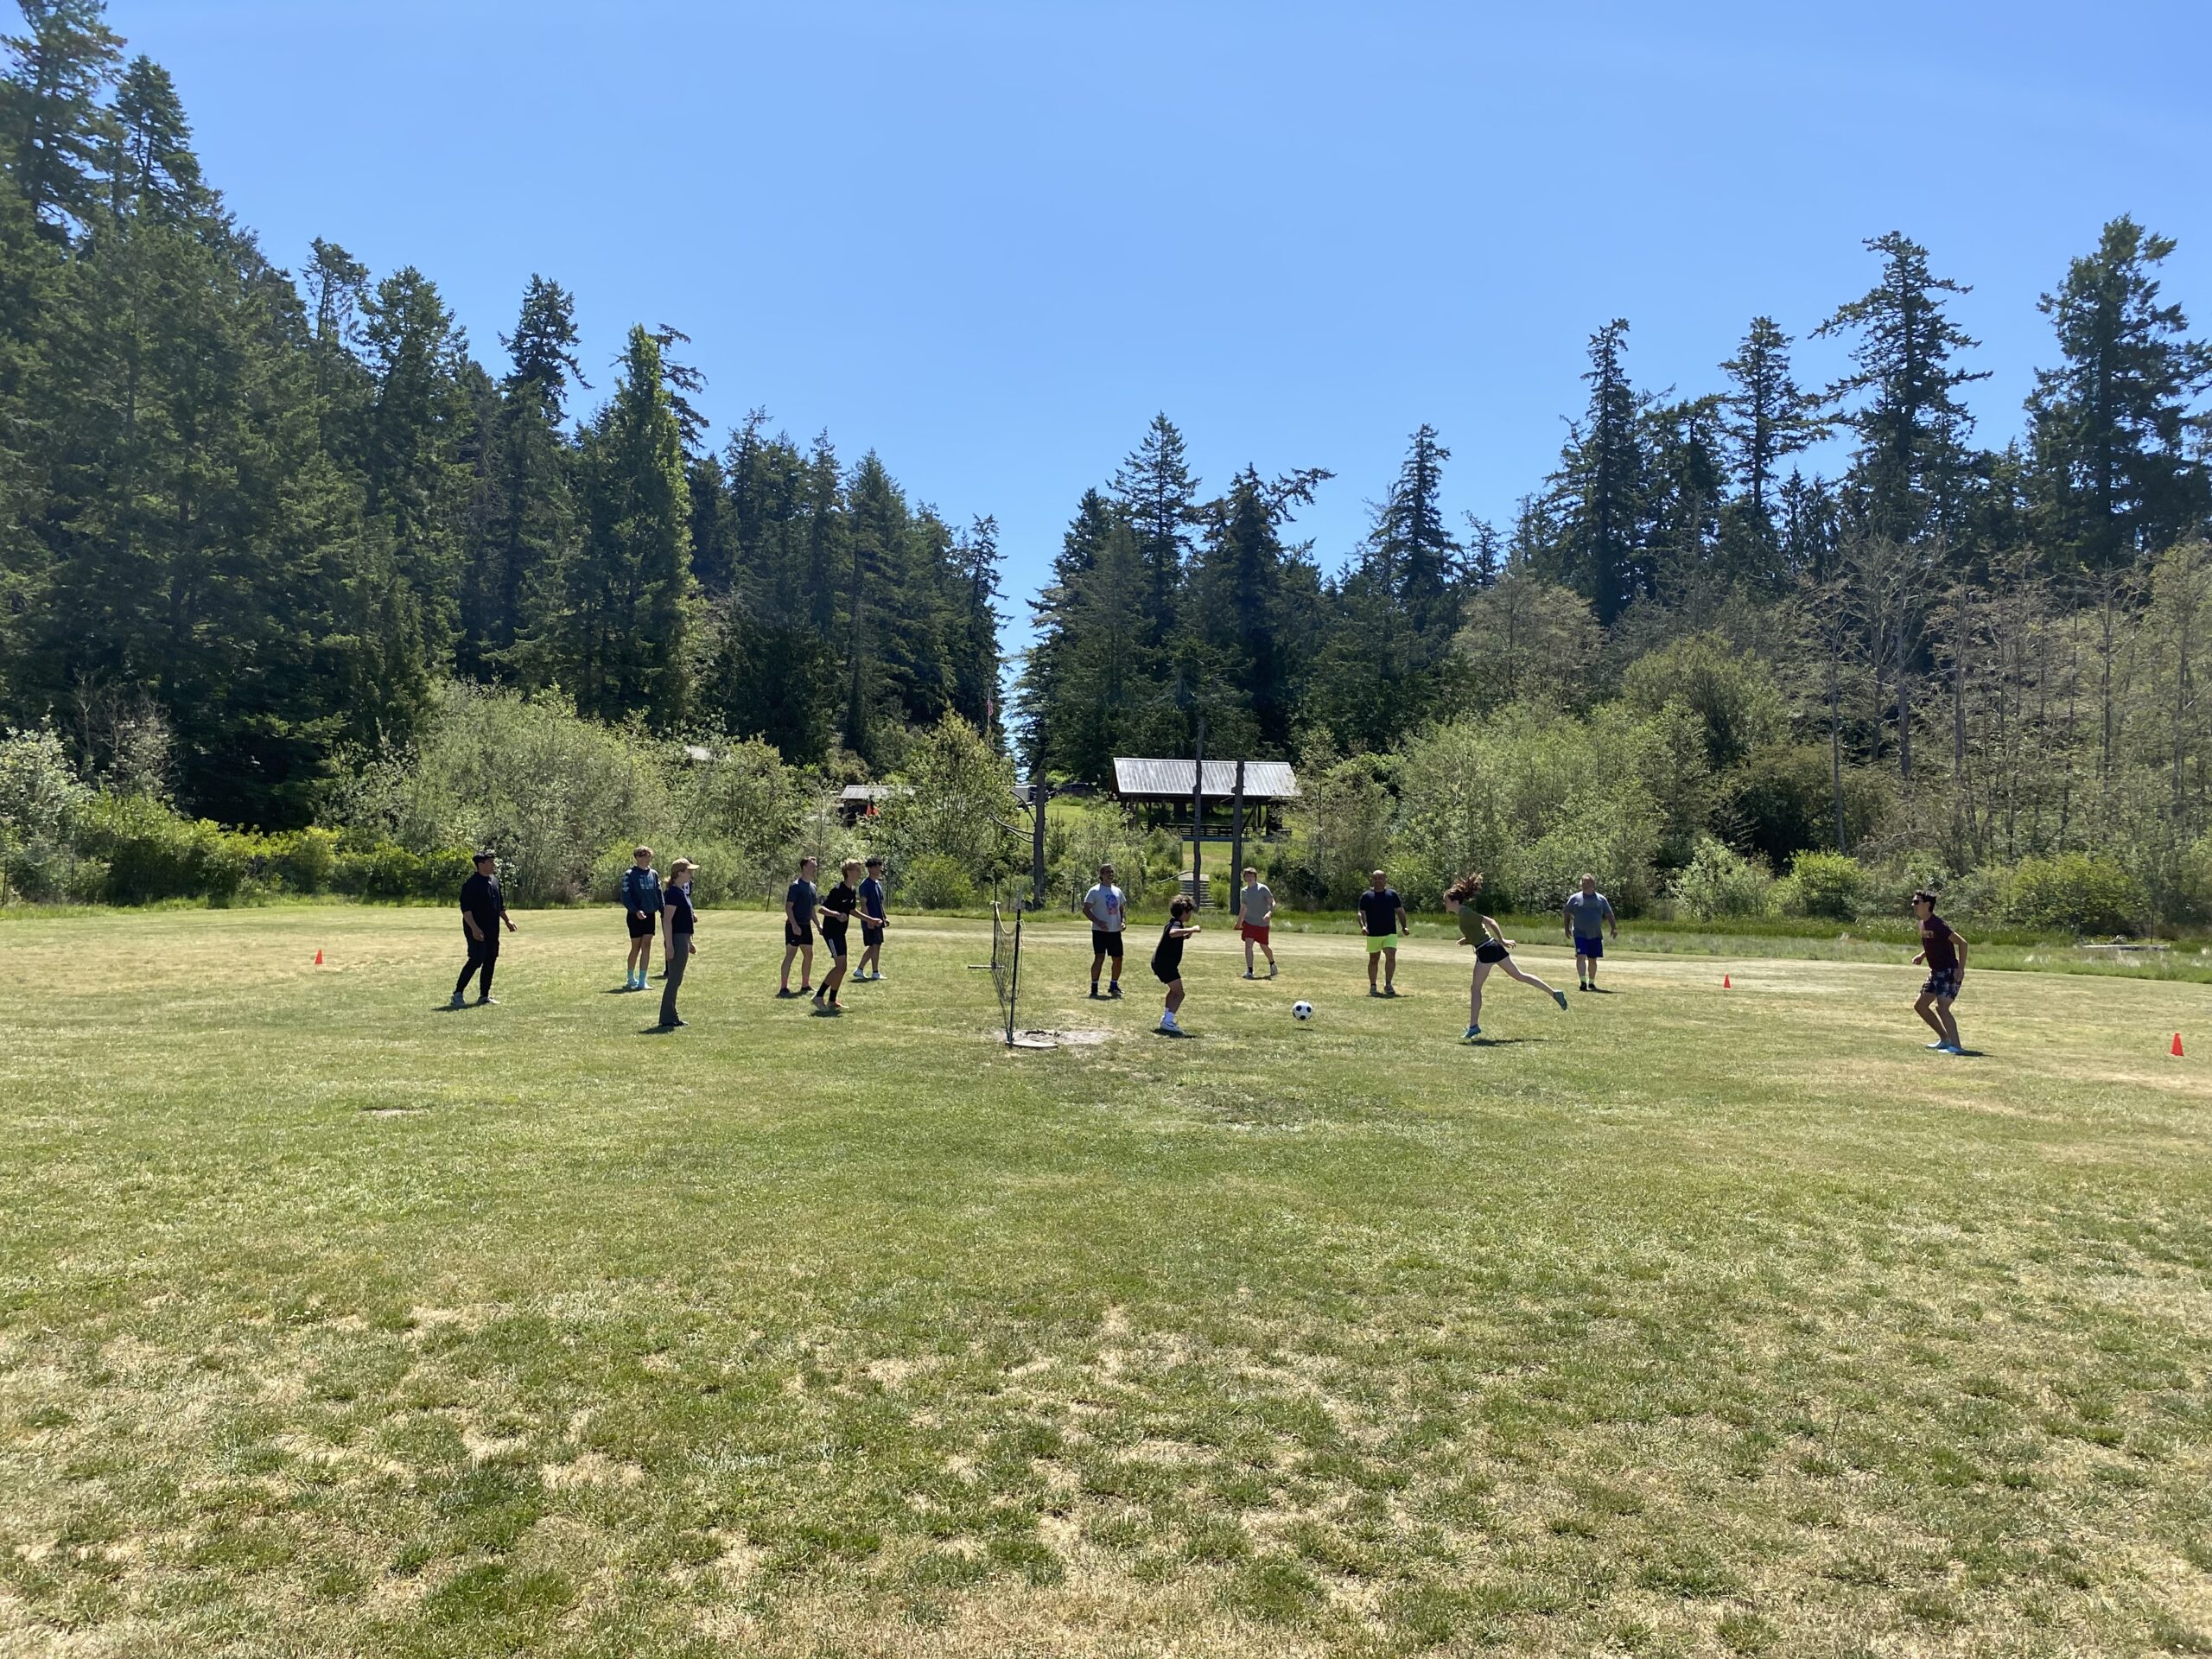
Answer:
[2029, 214, 2212, 573]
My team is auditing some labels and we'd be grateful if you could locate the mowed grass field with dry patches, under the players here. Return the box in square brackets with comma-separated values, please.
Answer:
[0, 907, 2212, 1659]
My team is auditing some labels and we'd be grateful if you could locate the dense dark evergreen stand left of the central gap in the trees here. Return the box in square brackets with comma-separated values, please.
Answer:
[0, 0, 1000, 830]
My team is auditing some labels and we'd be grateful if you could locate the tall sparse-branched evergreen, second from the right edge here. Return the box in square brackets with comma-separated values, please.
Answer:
[1816, 230, 1988, 542]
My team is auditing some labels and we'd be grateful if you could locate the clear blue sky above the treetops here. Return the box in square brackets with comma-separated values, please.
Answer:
[111, 0, 2212, 650]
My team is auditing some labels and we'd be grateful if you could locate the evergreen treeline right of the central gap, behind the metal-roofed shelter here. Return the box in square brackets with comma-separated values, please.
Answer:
[1022, 214, 2212, 911]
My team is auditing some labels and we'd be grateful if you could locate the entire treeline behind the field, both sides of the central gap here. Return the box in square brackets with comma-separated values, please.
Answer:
[0, 0, 2212, 925]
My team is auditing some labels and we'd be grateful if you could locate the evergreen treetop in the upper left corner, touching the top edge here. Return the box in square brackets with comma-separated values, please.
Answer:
[0, 0, 124, 238]
